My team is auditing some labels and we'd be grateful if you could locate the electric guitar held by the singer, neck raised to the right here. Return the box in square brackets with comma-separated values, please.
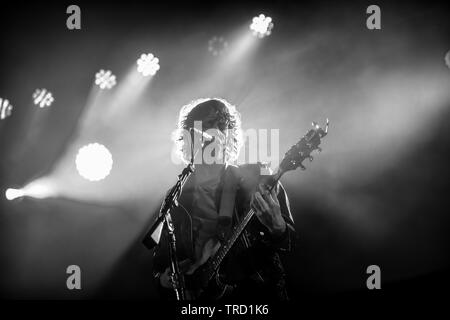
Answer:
[179, 119, 329, 300]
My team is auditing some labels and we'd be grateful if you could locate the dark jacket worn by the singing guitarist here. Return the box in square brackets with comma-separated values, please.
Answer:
[144, 164, 296, 301]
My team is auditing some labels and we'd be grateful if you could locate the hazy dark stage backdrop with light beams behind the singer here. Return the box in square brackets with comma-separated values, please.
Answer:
[0, 1, 450, 300]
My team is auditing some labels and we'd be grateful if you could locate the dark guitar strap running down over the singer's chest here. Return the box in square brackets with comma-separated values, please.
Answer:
[217, 165, 239, 240]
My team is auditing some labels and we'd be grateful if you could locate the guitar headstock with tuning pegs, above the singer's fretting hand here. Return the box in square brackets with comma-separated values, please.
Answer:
[279, 119, 329, 173]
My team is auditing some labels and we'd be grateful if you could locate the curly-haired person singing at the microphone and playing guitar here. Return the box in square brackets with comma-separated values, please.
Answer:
[144, 98, 295, 301]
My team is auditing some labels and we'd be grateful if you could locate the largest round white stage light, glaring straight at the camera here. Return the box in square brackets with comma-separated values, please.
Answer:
[75, 143, 113, 181]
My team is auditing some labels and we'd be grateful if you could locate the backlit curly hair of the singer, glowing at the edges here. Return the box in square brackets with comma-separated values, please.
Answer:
[172, 98, 243, 163]
